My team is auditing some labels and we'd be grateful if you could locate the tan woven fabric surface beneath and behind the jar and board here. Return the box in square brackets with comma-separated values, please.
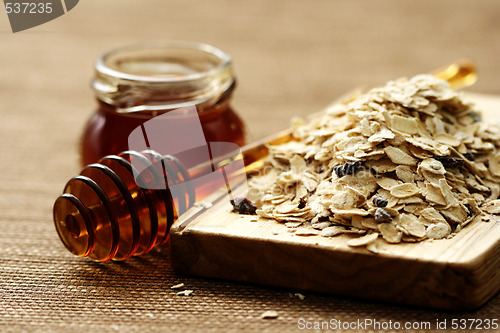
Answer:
[0, 0, 500, 332]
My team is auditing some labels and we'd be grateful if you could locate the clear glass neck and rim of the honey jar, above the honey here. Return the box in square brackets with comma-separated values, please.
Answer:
[92, 42, 235, 113]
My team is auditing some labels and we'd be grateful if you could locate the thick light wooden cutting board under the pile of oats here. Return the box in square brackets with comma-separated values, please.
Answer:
[170, 94, 500, 310]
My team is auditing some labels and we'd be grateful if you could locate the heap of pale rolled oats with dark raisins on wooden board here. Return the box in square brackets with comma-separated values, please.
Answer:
[247, 75, 500, 251]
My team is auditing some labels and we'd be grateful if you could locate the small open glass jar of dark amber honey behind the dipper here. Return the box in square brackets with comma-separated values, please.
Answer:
[81, 41, 245, 166]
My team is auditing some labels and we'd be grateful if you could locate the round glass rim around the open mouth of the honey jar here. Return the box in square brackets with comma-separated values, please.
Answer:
[94, 40, 232, 84]
